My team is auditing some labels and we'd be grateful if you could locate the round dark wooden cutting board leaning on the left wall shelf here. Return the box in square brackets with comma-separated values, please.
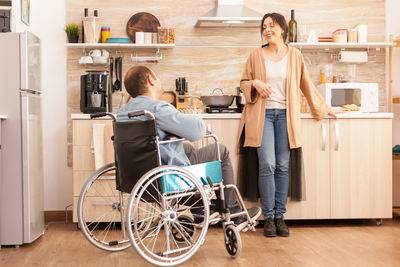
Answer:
[126, 12, 160, 43]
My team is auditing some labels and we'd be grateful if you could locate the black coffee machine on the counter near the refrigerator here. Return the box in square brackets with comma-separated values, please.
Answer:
[80, 70, 112, 113]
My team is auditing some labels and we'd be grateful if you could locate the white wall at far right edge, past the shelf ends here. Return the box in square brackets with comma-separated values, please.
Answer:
[386, 0, 400, 146]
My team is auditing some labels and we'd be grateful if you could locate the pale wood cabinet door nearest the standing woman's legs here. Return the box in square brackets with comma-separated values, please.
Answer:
[285, 119, 330, 219]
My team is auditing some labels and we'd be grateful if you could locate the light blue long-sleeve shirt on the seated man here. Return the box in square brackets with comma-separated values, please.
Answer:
[117, 95, 206, 166]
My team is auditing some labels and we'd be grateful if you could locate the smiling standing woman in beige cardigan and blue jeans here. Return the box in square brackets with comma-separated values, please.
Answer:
[239, 13, 336, 237]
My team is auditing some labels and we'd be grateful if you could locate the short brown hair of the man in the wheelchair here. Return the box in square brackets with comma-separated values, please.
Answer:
[124, 66, 156, 97]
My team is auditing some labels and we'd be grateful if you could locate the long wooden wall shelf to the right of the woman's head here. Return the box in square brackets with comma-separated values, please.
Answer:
[289, 42, 396, 50]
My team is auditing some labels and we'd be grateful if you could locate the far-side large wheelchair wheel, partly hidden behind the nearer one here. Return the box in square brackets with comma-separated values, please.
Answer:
[78, 163, 143, 251]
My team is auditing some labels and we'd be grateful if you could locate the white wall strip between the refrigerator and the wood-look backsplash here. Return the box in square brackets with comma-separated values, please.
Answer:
[11, 0, 72, 210]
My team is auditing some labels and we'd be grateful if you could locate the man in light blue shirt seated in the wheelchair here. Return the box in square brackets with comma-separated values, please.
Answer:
[117, 66, 261, 227]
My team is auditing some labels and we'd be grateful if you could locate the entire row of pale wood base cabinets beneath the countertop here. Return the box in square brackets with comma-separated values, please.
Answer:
[73, 114, 392, 222]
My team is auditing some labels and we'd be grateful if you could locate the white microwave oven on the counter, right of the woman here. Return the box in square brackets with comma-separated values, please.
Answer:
[317, 83, 379, 112]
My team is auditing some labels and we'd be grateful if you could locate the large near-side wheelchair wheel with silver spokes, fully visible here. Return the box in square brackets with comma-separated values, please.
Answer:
[126, 166, 209, 266]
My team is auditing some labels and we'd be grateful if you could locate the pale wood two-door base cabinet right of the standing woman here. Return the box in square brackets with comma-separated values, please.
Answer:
[286, 118, 392, 219]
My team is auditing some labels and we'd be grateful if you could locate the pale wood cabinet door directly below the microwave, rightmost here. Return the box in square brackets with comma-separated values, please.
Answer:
[330, 119, 392, 218]
